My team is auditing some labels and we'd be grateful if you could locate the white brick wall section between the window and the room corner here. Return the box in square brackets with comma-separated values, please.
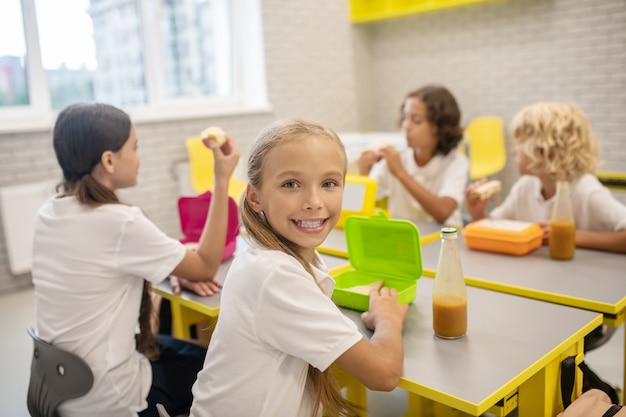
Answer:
[263, 0, 360, 131]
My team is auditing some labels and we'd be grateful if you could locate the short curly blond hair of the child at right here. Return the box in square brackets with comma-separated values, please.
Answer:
[511, 102, 599, 181]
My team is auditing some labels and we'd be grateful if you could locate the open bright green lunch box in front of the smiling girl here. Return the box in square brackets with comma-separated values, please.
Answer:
[331, 212, 422, 311]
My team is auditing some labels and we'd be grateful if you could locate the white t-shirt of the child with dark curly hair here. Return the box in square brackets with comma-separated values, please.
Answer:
[370, 148, 469, 226]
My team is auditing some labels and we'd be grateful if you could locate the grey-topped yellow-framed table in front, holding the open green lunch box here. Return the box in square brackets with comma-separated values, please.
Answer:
[154, 256, 602, 417]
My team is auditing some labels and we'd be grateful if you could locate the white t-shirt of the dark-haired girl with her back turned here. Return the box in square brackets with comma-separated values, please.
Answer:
[32, 197, 186, 417]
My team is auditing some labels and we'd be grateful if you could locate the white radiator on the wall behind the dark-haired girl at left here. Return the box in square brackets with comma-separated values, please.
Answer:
[0, 181, 56, 275]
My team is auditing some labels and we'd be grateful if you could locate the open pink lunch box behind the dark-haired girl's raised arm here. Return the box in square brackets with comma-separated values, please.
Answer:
[178, 191, 239, 260]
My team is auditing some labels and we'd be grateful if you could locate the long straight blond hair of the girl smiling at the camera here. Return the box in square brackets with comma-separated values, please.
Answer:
[240, 119, 356, 417]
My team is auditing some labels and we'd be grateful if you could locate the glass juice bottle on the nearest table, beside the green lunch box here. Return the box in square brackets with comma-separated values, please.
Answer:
[433, 227, 467, 339]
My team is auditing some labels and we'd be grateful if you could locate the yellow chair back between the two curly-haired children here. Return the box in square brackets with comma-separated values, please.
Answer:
[465, 116, 506, 180]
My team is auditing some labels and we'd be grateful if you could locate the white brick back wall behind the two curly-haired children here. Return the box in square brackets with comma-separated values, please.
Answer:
[358, 0, 626, 187]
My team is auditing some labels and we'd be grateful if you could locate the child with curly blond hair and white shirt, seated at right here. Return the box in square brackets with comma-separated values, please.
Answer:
[465, 102, 626, 253]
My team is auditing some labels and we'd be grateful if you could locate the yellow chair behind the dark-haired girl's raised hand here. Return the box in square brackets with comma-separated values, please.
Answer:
[185, 136, 248, 204]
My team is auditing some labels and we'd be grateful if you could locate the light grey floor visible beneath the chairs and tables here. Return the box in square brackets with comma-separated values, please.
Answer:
[0, 289, 624, 417]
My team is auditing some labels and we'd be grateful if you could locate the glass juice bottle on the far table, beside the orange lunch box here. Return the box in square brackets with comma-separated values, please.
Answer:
[549, 181, 576, 260]
